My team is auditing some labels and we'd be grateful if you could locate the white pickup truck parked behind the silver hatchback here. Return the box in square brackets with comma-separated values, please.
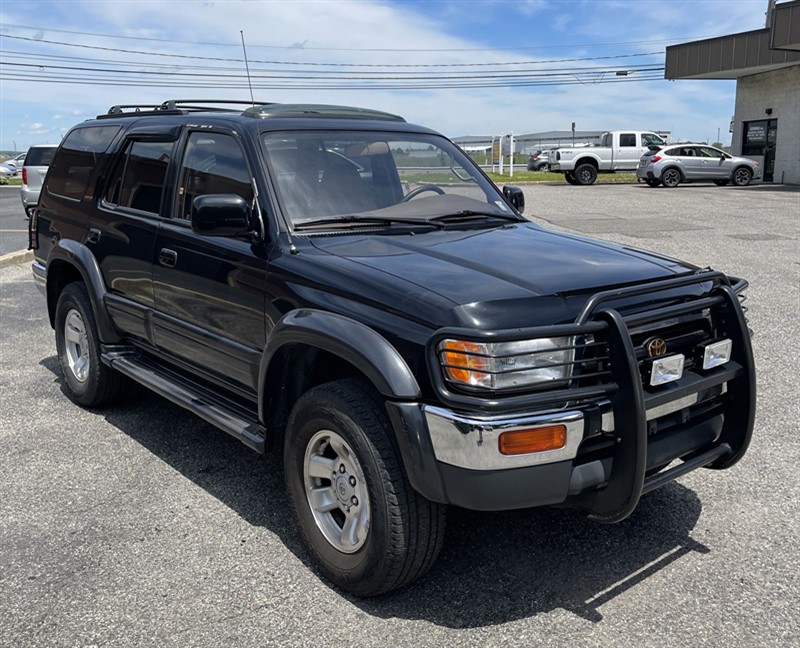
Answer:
[547, 131, 666, 185]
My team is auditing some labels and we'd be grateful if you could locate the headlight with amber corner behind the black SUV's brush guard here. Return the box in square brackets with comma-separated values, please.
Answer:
[438, 337, 575, 390]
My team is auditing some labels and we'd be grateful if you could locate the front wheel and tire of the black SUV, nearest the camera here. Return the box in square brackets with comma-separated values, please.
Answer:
[283, 379, 446, 596]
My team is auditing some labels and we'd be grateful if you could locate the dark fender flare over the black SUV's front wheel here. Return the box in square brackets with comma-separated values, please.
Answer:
[258, 308, 421, 420]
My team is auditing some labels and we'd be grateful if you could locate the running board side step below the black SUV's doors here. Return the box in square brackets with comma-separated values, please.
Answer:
[101, 350, 265, 453]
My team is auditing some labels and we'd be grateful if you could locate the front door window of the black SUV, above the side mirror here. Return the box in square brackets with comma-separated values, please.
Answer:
[176, 133, 253, 220]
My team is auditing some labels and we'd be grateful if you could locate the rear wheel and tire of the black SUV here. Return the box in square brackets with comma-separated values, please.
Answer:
[55, 282, 129, 407]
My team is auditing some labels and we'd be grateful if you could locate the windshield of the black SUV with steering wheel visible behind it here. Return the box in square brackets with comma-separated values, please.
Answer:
[262, 131, 512, 226]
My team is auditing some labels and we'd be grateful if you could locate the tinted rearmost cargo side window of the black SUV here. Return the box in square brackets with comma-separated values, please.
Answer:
[47, 126, 120, 200]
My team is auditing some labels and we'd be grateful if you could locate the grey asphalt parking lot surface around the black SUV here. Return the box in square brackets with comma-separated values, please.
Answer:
[0, 184, 800, 648]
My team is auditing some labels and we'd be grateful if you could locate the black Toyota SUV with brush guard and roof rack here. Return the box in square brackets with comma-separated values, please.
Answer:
[30, 101, 755, 596]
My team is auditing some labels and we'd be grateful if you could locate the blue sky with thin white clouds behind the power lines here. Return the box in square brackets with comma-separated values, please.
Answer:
[0, 0, 767, 151]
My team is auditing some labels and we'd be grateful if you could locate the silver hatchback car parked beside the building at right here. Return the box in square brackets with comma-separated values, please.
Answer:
[636, 144, 761, 187]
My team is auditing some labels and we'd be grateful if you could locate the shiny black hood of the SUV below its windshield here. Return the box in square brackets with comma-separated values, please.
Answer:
[304, 223, 696, 326]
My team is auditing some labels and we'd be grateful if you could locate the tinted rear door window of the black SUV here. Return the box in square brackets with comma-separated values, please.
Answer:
[105, 141, 172, 214]
